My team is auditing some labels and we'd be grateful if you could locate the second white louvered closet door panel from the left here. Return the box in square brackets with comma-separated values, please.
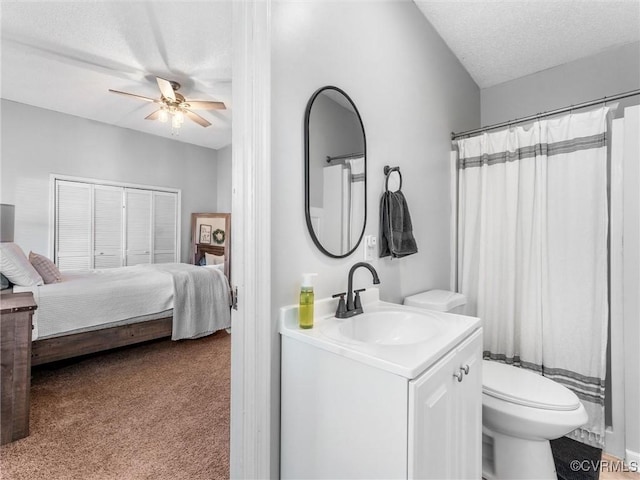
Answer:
[93, 185, 124, 268]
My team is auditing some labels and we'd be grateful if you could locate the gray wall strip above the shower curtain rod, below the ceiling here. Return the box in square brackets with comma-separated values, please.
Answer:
[480, 42, 640, 126]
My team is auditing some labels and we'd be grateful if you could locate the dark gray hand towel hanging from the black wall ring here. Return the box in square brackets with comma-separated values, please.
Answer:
[380, 190, 418, 258]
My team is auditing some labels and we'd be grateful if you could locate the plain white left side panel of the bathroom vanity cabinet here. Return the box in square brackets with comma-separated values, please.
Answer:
[280, 337, 407, 480]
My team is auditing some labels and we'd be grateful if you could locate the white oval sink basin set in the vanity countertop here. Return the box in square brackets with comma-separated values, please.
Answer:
[338, 311, 442, 345]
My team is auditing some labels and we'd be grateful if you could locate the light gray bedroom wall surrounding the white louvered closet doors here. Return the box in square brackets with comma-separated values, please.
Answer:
[0, 100, 218, 262]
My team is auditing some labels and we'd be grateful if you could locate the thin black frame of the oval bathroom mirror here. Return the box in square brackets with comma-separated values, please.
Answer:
[304, 85, 367, 258]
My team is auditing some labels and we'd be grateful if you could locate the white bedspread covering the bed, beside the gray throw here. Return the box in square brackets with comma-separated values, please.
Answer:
[14, 264, 230, 340]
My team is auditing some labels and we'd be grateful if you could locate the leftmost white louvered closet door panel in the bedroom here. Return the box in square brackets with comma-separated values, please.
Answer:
[55, 180, 92, 271]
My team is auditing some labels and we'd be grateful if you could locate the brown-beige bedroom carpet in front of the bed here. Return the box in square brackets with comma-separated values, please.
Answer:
[0, 331, 231, 480]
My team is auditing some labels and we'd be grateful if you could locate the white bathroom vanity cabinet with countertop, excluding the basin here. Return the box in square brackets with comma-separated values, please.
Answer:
[280, 296, 482, 479]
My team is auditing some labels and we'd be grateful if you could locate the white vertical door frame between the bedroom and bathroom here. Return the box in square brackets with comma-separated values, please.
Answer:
[230, 0, 278, 478]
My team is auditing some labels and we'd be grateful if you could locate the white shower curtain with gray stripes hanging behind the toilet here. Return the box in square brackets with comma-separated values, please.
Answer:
[454, 108, 608, 447]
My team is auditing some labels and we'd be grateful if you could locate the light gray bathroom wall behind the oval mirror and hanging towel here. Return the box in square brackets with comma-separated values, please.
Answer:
[271, 0, 480, 472]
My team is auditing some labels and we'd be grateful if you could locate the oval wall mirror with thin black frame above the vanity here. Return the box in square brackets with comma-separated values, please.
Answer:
[304, 87, 367, 258]
